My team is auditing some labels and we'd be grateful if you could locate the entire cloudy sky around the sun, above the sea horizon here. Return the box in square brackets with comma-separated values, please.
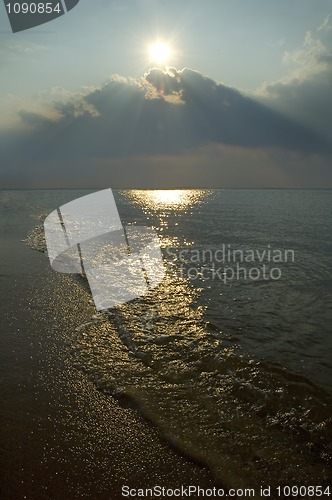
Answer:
[0, 0, 332, 189]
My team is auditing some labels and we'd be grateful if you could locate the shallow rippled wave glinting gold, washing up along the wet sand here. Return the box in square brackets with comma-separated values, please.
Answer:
[75, 277, 332, 487]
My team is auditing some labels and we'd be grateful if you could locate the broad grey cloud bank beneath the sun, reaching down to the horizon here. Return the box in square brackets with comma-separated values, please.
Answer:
[0, 64, 332, 188]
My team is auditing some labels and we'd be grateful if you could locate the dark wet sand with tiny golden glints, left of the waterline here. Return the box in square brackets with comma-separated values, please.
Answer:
[0, 243, 216, 500]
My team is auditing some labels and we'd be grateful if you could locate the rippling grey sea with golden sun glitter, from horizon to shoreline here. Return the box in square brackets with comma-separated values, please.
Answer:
[0, 189, 332, 498]
